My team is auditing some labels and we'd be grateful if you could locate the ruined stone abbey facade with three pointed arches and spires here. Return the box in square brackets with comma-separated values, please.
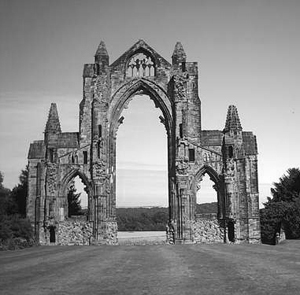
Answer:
[27, 40, 260, 244]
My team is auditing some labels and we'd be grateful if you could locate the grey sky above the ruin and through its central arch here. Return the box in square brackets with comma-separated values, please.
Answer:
[0, 0, 300, 206]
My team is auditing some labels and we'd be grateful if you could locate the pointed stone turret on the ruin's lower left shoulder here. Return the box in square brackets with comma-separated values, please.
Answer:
[45, 103, 61, 148]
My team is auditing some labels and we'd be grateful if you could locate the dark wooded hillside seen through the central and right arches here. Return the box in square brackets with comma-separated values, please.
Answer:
[117, 202, 218, 231]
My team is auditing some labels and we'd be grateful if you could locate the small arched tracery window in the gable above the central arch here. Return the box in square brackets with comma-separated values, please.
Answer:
[126, 52, 155, 77]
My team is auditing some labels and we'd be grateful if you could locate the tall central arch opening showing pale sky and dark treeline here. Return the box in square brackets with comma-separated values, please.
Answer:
[116, 94, 168, 232]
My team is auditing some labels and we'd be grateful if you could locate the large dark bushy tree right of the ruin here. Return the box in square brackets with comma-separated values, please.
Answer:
[260, 168, 300, 244]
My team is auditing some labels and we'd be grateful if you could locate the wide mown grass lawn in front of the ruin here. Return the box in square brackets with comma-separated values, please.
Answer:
[0, 241, 300, 295]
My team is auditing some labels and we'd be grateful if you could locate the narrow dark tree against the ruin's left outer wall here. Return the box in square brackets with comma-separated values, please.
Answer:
[11, 165, 28, 217]
